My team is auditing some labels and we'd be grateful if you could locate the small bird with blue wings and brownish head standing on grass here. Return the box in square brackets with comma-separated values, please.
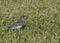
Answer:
[5, 16, 26, 30]
